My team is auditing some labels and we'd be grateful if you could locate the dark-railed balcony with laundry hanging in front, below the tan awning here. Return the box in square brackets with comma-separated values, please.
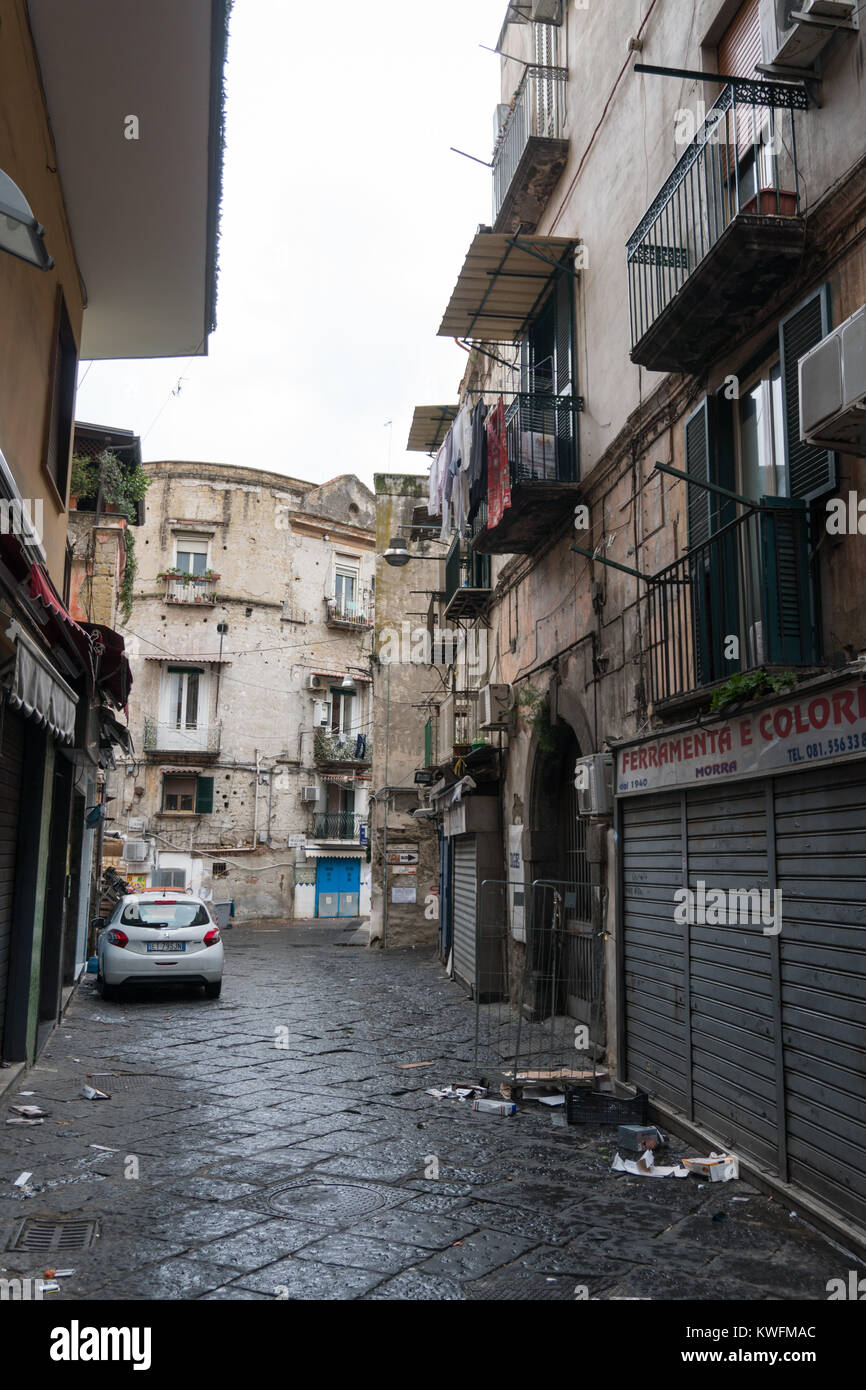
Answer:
[473, 392, 584, 555]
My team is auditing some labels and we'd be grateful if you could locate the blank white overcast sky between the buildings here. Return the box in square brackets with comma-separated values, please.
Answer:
[76, 0, 506, 485]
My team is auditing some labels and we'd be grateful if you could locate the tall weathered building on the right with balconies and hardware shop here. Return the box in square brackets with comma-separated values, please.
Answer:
[403, 0, 866, 1245]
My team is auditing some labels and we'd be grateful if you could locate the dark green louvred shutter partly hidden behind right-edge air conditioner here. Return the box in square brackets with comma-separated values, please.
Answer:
[778, 285, 835, 502]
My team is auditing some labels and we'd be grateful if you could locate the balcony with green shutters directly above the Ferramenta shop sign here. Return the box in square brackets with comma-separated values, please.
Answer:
[649, 498, 817, 705]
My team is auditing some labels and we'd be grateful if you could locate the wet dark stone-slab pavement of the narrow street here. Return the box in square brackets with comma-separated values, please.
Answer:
[0, 923, 851, 1301]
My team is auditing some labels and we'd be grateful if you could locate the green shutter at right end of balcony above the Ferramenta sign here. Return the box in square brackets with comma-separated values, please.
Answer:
[760, 498, 816, 666]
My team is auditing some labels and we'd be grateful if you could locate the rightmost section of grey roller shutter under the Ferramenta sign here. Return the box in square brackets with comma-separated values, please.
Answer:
[776, 763, 866, 1226]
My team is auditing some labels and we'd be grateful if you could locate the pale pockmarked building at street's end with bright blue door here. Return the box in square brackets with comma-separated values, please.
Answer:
[108, 461, 374, 919]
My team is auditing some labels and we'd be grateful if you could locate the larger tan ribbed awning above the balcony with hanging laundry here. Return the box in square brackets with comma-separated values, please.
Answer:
[439, 232, 577, 343]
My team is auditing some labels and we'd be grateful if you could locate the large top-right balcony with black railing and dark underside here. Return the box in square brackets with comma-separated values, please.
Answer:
[628, 81, 808, 373]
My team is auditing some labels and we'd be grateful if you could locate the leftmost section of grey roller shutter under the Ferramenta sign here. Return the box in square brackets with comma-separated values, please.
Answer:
[623, 792, 688, 1109]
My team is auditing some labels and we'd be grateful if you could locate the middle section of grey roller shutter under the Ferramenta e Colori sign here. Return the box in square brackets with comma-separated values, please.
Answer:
[687, 781, 778, 1168]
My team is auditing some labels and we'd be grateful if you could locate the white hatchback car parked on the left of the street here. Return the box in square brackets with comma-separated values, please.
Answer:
[93, 888, 222, 999]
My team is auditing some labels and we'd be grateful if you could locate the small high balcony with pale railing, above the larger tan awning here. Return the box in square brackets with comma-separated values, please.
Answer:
[493, 65, 569, 232]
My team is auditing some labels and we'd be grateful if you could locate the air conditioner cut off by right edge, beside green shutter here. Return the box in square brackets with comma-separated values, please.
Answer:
[799, 304, 866, 457]
